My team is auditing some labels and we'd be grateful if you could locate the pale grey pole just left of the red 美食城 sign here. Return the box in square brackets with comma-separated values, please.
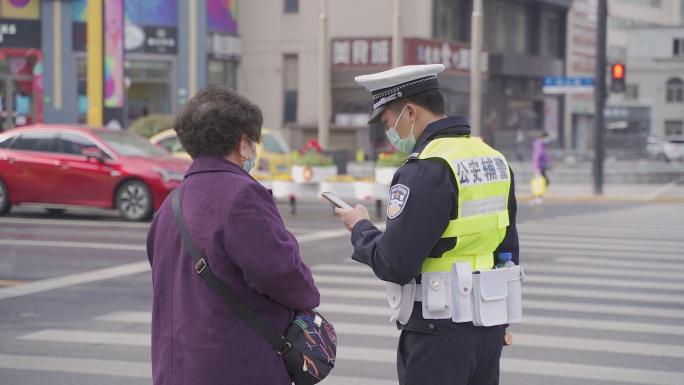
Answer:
[318, 0, 330, 149]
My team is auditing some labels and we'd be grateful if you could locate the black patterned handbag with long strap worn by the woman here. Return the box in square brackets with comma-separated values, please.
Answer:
[172, 188, 337, 385]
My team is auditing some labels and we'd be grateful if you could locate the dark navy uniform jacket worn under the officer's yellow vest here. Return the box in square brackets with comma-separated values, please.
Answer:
[352, 117, 518, 334]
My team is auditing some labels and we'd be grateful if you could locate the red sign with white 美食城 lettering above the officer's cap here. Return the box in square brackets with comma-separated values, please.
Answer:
[331, 38, 392, 68]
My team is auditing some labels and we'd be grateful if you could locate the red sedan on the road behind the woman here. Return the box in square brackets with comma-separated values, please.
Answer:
[0, 125, 190, 221]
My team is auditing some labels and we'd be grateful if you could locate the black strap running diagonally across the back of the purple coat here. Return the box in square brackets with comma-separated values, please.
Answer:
[172, 188, 292, 356]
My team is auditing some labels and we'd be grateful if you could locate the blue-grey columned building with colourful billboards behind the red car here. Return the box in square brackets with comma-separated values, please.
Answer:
[0, 0, 241, 129]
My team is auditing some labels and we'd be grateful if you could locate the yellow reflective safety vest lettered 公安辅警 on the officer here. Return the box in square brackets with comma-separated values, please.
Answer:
[418, 137, 511, 273]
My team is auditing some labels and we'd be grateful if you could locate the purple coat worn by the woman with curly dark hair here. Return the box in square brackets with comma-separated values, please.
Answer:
[147, 157, 320, 385]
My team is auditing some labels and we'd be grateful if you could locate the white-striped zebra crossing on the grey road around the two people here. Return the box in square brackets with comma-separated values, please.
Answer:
[5, 204, 684, 385]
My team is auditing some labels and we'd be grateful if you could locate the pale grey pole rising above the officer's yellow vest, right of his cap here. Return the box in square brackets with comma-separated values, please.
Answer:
[470, 0, 483, 136]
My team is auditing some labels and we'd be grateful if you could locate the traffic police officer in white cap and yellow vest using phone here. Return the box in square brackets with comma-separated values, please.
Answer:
[336, 64, 518, 385]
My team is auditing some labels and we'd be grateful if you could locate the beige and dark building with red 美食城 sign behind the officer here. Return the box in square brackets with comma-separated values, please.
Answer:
[239, 0, 571, 156]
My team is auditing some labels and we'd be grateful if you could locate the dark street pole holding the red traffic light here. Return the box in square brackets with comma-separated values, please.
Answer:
[594, 0, 608, 195]
